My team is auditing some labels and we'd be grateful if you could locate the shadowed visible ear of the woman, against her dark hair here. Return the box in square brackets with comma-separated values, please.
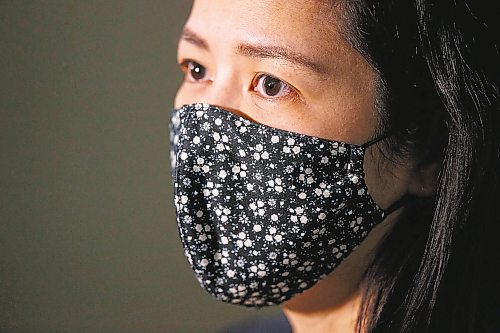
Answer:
[408, 162, 441, 197]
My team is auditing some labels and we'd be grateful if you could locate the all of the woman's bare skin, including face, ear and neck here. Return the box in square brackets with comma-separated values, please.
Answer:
[175, 0, 433, 333]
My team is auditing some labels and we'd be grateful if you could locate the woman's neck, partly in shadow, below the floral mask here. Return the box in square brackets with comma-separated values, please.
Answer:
[282, 214, 397, 333]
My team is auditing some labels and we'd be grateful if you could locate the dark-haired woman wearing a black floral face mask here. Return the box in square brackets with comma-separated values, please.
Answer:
[172, 0, 500, 333]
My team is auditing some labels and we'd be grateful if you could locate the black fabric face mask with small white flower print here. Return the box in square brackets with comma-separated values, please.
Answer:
[170, 104, 400, 307]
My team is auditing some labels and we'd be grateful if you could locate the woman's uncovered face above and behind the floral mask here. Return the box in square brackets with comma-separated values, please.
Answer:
[175, 0, 418, 219]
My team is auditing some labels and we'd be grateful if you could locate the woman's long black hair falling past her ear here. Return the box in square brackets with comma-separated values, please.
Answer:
[330, 0, 500, 333]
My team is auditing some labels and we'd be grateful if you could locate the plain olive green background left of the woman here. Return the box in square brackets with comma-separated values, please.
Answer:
[0, 0, 276, 332]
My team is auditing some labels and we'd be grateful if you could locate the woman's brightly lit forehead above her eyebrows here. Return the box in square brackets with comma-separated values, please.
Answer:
[186, 0, 352, 66]
